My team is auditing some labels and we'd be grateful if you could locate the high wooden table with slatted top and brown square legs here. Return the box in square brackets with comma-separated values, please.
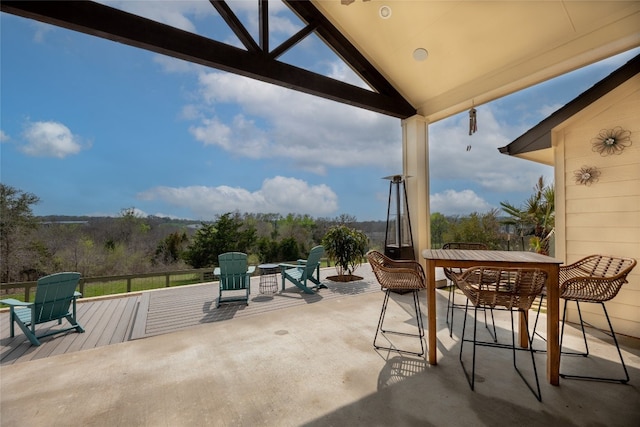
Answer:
[422, 249, 562, 385]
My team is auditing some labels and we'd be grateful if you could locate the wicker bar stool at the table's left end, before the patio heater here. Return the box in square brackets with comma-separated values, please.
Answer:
[367, 251, 426, 356]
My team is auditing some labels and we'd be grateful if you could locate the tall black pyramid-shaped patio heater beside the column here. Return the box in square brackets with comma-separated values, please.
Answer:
[383, 175, 415, 260]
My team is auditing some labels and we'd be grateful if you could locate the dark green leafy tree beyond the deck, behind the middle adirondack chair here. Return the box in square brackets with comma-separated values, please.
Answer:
[183, 213, 256, 268]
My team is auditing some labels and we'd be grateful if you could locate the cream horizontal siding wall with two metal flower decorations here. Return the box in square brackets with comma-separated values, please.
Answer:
[555, 76, 640, 337]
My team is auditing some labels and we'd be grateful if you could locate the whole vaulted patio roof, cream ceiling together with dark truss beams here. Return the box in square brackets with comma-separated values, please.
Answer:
[5, 0, 640, 121]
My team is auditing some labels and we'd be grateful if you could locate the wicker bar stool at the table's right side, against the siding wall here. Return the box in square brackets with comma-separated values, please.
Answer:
[560, 255, 637, 384]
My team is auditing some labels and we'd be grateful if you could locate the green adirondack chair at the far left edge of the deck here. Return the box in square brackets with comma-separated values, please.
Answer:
[0, 273, 84, 345]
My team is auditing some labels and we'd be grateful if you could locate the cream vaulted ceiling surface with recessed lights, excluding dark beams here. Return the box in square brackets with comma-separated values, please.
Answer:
[312, 0, 640, 121]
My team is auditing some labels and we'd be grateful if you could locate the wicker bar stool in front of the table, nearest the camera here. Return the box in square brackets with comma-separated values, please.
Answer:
[454, 267, 547, 401]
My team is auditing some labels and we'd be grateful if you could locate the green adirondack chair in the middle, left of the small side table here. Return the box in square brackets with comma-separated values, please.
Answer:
[213, 252, 256, 307]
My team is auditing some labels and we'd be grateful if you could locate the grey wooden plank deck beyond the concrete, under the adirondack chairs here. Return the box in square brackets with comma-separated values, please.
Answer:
[0, 265, 380, 365]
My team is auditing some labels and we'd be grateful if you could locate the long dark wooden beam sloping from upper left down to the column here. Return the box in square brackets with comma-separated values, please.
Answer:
[0, 1, 416, 118]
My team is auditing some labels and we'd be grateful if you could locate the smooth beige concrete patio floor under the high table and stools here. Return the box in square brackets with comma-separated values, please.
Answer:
[0, 265, 640, 427]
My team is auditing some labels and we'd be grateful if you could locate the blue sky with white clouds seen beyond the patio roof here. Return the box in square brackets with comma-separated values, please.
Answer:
[0, 1, 639, 220]
